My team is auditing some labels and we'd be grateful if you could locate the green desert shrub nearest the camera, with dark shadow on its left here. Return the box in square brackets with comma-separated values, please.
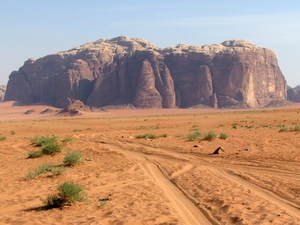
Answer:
[44, 181, 86, 209]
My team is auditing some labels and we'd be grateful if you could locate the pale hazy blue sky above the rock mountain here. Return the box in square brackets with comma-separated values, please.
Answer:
[0, 0, 300, 87]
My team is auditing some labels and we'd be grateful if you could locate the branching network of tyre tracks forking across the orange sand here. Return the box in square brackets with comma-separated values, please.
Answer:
[80, 134, 300, 224]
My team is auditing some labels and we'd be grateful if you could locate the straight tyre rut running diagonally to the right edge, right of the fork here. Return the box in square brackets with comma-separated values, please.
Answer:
[207, 166, 300, 219]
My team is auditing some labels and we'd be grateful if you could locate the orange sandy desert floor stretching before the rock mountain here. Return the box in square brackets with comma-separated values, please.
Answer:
[0, 102, 300, 225]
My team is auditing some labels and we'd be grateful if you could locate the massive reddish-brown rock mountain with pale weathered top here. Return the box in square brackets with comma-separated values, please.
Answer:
[5, 36, 287, 108]
